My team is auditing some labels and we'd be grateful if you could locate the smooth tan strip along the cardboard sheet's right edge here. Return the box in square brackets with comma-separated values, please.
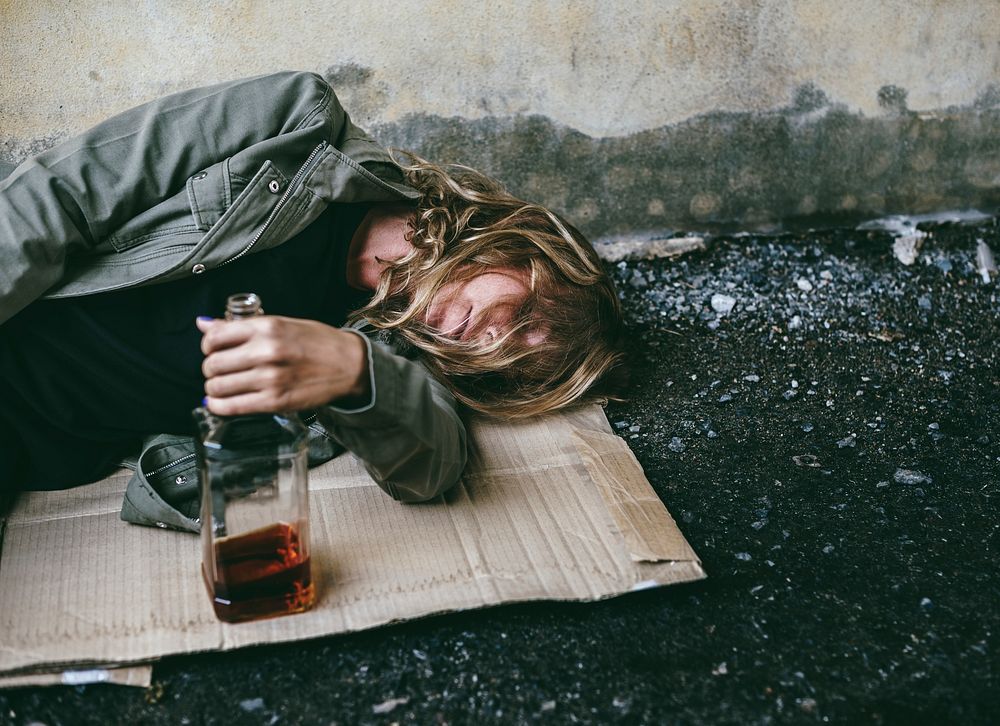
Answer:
[573, 429, 705, 584]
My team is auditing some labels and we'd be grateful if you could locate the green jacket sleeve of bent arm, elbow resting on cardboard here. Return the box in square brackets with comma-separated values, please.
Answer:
[317, 331, 468, 502]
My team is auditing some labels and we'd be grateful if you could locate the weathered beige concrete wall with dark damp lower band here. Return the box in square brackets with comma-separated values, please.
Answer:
[0, 0, 1000, 236]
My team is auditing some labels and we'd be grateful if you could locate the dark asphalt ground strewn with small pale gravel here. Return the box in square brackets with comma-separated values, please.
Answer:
[0, 221, 1000, 725]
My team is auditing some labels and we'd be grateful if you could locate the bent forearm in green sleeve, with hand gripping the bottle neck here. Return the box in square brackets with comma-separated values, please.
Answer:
[198, 316, 468, 502]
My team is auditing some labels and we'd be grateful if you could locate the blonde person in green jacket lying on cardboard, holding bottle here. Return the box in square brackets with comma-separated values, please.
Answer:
[0, 72, 623, 528]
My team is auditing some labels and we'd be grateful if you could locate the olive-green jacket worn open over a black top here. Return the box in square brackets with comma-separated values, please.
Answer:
[0, 72, 466, 528]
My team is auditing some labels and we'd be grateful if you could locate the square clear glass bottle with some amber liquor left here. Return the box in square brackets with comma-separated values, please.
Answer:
[193, 293, 316, 623]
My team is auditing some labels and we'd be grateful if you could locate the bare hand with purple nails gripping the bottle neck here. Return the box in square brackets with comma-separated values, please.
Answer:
[196, 315, 371, 416]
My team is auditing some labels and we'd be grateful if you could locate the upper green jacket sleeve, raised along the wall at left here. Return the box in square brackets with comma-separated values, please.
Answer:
[0, 72, 349, 324]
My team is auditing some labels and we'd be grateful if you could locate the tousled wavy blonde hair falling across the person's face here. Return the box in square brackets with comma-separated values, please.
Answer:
[354, 154, 624, 418]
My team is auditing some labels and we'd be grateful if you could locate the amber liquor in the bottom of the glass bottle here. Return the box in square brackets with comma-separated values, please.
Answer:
[203, 522, 316, 623]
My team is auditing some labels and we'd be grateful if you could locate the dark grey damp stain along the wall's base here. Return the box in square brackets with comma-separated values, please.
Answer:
[374, 86, 1000, 237]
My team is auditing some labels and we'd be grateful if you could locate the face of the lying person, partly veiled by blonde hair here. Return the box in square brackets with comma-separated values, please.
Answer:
[426, 268, 543, 345]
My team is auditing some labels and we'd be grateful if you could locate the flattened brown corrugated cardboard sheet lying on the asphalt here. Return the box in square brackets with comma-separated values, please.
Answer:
[0, 406, 705, 686]
